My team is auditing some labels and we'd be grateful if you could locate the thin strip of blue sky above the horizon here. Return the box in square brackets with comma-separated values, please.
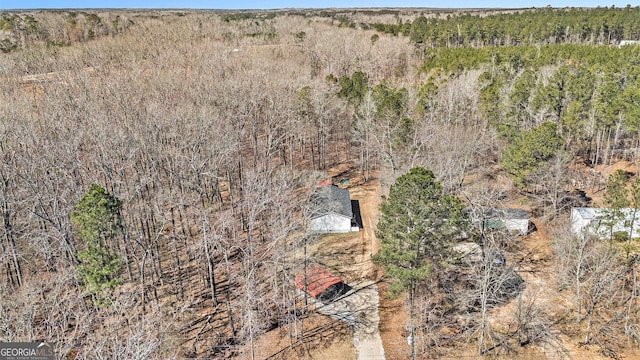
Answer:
[0, 0, 640, 9]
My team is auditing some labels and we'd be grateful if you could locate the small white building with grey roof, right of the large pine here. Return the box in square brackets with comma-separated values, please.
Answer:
[470, 208, 533, 235]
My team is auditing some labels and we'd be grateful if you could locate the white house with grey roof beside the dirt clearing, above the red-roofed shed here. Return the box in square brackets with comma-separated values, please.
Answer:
[309, 185, 360, 234]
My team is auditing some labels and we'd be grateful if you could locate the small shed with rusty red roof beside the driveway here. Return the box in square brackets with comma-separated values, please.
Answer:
[294, 266, 351, 302]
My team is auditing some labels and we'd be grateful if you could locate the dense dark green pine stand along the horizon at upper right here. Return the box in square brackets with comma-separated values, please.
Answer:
[370, 5, 640, 48]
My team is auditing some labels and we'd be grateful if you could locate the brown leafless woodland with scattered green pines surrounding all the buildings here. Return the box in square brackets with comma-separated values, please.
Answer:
[0, 6, 640, 359]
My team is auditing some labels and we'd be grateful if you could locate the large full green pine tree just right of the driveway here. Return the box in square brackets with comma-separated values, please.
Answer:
[373, 167, 466, 295]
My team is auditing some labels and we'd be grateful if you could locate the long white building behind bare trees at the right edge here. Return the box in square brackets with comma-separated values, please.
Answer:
[571, 208, 640, 239]
